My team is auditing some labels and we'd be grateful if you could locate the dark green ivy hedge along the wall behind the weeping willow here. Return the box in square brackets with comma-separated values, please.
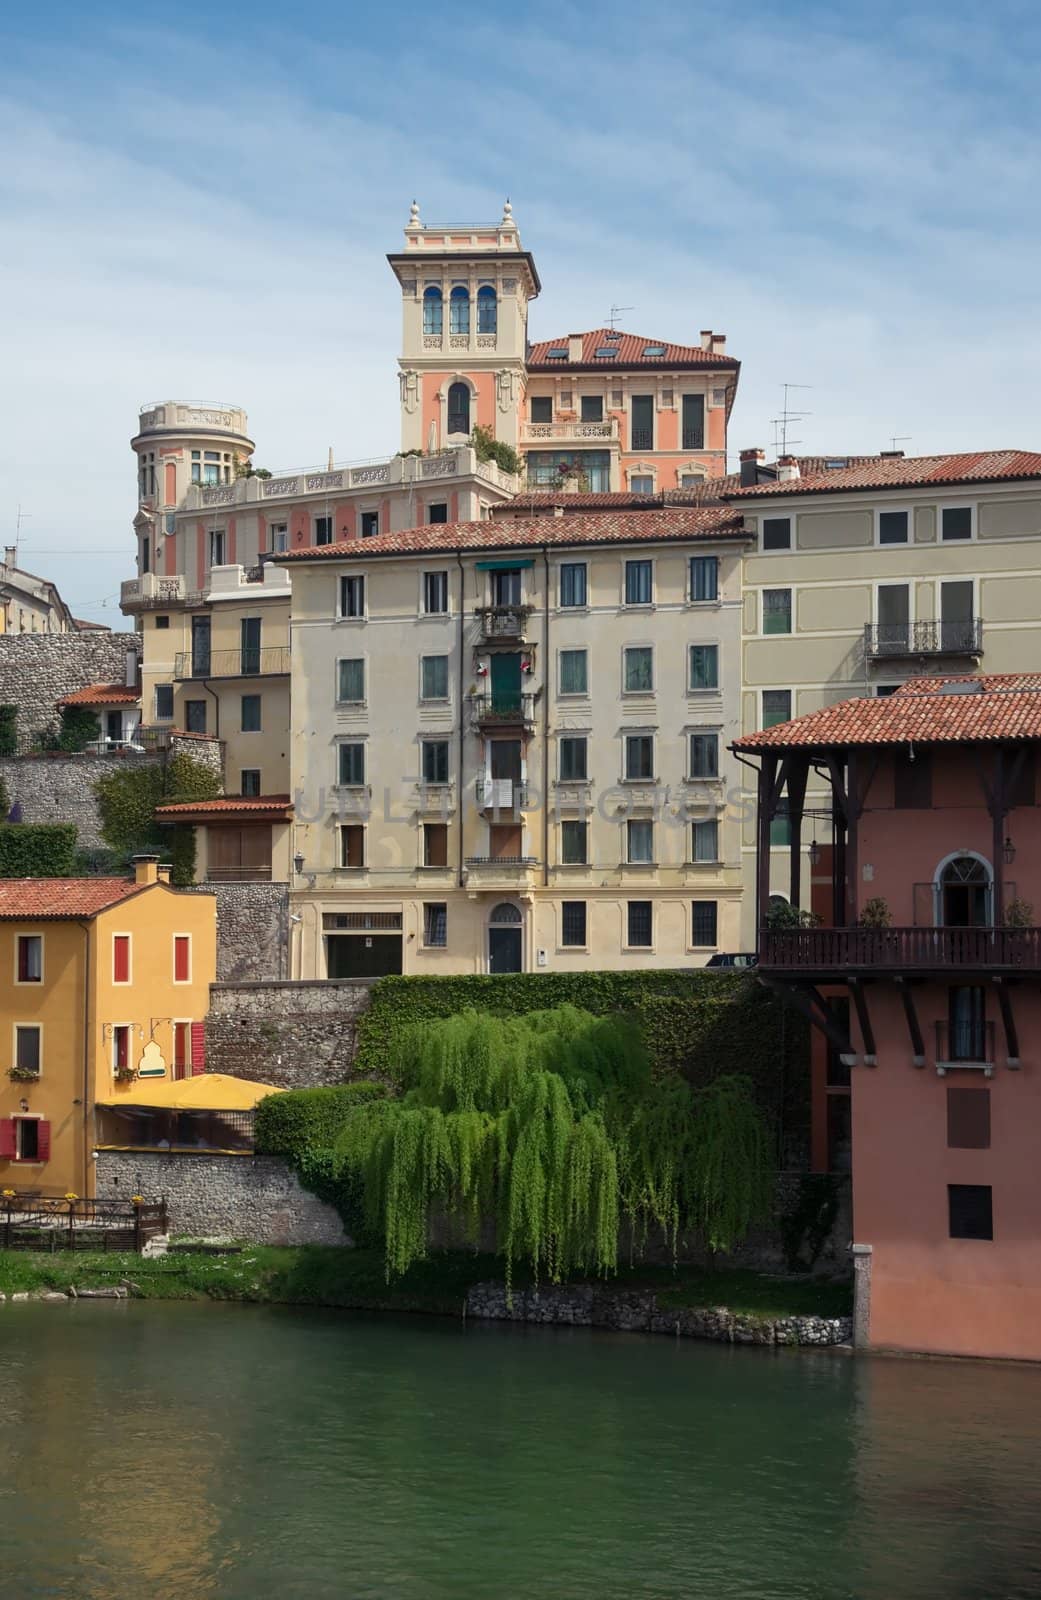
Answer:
[353, 966, 809, 1160]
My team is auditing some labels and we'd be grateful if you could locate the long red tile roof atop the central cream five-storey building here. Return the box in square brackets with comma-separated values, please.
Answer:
[275, 506, 753, 565]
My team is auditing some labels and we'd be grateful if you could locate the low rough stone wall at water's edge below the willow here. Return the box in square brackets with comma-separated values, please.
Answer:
[465, 1283, 852, 1344]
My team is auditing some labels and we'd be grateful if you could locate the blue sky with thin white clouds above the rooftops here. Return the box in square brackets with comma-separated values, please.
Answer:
[0, 0, 1041, 627]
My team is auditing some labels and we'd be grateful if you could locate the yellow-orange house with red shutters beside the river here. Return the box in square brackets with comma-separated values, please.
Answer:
[0, 856, 216, 1197]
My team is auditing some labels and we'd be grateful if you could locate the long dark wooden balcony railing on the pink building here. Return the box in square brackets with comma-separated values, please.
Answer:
[760, 928, 1041, 981]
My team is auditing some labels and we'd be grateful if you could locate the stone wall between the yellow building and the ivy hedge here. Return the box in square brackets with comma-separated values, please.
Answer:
[206, 979, 369, 1090]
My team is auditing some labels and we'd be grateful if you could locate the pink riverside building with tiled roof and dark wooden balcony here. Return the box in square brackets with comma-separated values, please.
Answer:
[736, 674, 1041, 1360]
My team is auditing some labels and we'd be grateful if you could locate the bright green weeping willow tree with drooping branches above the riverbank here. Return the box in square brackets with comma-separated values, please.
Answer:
[334, 1006, 771, 1282]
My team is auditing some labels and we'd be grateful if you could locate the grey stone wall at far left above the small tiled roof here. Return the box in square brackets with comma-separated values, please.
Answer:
[0, 632, 141, 738]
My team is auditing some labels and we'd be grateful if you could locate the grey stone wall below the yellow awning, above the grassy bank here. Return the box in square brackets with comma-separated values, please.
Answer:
[96, 1150, 350, 1245]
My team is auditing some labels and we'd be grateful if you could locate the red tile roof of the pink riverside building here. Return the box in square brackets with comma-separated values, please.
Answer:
[734, 672, 1041, 750]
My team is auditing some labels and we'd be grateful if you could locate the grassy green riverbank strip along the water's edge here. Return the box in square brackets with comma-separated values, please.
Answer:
[0, 1245, 851, 1318]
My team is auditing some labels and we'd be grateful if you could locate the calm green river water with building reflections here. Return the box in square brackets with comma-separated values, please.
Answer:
[0, 1301, 1041, 1600]
